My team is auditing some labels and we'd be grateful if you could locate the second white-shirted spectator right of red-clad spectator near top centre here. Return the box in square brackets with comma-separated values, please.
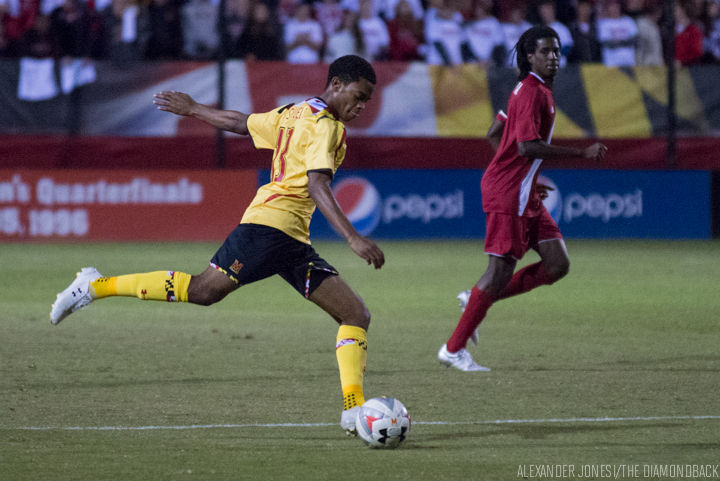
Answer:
[465, 0, 507, 67]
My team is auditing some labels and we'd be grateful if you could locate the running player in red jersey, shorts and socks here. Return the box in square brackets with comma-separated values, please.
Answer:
[438, 26, 607, 371]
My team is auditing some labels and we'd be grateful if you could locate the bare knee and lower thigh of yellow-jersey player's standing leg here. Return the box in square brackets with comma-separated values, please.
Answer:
[308, 275, 370, 329]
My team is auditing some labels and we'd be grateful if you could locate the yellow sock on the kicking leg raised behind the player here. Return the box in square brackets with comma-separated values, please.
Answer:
[90, 271, 191, 302]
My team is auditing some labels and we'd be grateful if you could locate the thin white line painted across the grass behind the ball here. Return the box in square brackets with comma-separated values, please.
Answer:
[11, 415, 720, 431]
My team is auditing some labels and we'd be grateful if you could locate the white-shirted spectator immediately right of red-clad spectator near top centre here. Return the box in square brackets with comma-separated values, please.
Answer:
[425, 0, 474, 66]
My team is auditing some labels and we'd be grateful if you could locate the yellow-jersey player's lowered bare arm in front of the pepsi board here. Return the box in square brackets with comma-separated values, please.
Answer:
[307, 171, 385, 269]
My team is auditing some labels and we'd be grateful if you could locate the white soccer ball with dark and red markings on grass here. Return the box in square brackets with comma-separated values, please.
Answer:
[355, 396, 410, 449]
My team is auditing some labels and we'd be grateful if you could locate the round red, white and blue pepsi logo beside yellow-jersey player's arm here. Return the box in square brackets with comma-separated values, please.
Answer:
[333, 177, 382, 235]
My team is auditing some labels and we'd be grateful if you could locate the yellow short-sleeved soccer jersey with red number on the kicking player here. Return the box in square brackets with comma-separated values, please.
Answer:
[240, 98, 346, 244]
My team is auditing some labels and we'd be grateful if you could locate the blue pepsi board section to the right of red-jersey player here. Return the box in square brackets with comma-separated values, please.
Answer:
[538, 170, 711, 239]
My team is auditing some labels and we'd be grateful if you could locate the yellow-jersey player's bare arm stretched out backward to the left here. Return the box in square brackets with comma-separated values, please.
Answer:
[153, 91, 249, 135]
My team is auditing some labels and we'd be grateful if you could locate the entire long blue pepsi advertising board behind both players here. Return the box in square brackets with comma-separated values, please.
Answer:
[260, 169, 711, 239]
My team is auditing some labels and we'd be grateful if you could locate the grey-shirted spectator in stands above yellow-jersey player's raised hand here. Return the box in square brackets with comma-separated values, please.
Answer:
[182, 0, 220, 60]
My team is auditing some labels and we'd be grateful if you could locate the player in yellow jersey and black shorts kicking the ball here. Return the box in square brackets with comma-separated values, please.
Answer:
[50, 55, 385, 433]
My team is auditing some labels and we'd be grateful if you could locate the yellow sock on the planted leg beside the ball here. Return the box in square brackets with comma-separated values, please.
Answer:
[335, 325, 367, 409]
